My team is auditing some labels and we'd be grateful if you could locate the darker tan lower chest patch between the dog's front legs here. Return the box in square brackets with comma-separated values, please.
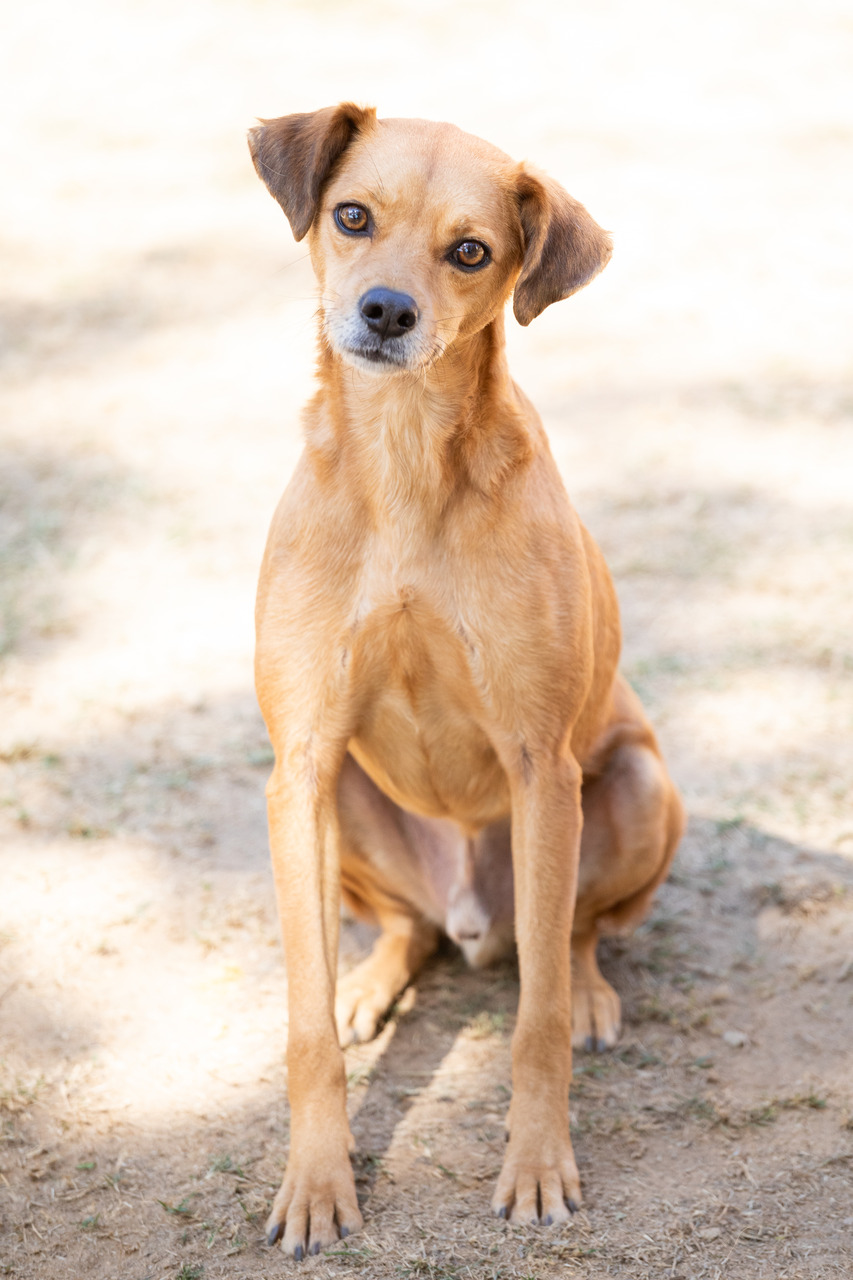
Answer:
[350, 607, 510, 831]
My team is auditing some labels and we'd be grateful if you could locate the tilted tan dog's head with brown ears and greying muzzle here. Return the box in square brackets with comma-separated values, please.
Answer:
[248, 102, 611, 374]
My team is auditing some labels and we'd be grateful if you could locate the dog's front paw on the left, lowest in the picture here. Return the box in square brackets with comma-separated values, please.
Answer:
[265, 1160, 361, 1262]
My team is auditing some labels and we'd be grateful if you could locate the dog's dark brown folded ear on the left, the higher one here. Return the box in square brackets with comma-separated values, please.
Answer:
[248, 102, 377, 241]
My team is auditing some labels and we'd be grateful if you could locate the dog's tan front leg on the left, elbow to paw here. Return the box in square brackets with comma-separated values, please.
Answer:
[266, 737, 361, 1260]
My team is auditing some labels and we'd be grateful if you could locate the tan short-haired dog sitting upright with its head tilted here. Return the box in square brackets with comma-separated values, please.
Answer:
[250, 104, 683, 1258]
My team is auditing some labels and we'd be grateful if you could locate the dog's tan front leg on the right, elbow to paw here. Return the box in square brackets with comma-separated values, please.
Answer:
[492, 755, 583, 1224]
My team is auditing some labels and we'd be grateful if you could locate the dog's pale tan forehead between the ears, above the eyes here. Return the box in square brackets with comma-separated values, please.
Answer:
[329, 119, 519, 227]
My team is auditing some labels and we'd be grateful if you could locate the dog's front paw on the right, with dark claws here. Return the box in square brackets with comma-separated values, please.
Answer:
[492, 1126, 581, 1226]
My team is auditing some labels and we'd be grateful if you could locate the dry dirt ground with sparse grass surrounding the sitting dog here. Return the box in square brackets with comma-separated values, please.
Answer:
[0, 0, 853, 1280]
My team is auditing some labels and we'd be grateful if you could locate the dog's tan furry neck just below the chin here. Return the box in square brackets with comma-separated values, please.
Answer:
[306, 315, 534, 527]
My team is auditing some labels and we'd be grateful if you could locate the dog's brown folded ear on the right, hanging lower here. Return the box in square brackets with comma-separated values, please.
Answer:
[512, 169, 612, 325]
